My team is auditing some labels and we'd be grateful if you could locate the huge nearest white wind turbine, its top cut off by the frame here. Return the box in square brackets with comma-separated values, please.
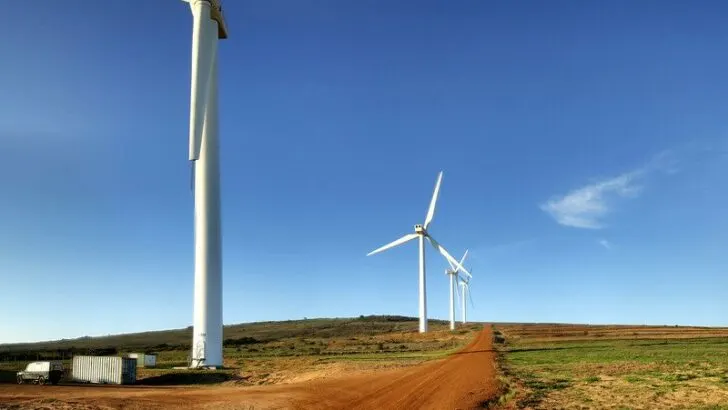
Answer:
[183, 0, 227, 368]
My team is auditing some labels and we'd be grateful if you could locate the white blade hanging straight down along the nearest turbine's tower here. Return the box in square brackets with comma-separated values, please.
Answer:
[189, 1, 218, 161]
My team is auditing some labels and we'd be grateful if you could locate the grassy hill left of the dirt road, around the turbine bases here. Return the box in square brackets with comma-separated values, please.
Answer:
[0, 316, 482, 385]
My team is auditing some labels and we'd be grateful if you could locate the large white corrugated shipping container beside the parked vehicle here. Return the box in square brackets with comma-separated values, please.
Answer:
[71, 356, 136, 384]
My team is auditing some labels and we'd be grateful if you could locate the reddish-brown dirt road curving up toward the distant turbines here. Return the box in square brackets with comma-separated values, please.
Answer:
[0, 327, 497, 410]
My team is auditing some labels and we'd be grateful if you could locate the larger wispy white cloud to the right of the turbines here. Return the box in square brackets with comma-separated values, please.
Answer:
[540, 151, 678, 229]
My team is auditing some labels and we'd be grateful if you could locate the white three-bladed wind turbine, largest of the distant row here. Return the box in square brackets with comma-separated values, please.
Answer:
[367, 171, 468, 333]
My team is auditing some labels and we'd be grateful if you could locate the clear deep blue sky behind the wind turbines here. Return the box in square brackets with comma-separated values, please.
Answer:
[0, 0, 728, 342]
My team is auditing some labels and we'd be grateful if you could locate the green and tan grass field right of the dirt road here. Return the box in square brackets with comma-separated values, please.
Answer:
[497, 327, 728, 409]
